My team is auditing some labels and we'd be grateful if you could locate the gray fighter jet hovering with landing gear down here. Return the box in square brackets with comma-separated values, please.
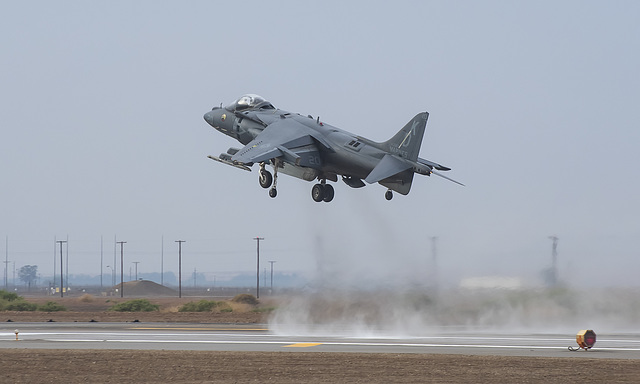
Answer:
[204, 94, 462, 202]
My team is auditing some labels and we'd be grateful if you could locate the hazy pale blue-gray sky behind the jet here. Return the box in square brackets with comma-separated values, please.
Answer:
[0, 1, 640, 286]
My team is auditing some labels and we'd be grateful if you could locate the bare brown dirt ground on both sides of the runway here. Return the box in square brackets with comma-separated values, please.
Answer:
[0, 295, 640, 384]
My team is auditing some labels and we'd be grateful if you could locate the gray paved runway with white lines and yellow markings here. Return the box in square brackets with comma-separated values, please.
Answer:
[0, 323, 640, 359]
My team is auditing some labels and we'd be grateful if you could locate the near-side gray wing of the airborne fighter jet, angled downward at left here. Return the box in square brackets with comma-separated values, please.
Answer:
[231, 119, 321, 168]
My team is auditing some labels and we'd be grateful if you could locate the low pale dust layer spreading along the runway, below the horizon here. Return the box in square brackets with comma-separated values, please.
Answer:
[269, 286, 640, 337]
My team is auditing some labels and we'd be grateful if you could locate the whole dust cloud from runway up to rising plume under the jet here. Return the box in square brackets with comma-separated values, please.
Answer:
[269, 194, 640, 337]
